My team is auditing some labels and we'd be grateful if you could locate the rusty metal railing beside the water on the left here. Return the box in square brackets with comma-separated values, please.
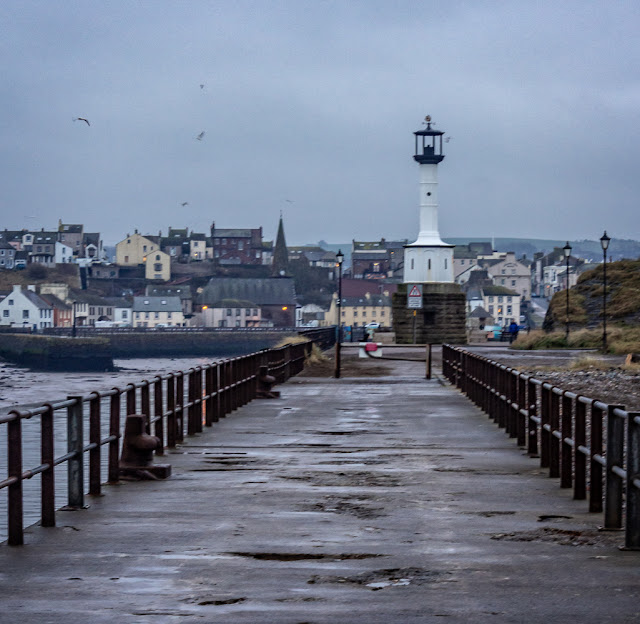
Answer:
[0, 341, 312, 546]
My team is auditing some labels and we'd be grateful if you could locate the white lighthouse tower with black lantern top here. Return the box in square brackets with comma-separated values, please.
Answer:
[404, 115, 454, 284]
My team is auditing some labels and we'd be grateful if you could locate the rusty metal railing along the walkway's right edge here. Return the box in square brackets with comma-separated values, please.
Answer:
[442, 345, 640, 550]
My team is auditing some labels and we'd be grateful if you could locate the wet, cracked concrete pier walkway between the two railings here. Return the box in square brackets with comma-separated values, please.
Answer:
[0, 362, 640, 624]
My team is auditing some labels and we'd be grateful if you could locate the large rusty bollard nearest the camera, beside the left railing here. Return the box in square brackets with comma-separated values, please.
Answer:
[120, 414, 171, 481]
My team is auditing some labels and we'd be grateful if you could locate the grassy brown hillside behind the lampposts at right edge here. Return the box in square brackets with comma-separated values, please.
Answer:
[542, 260, 640, 331]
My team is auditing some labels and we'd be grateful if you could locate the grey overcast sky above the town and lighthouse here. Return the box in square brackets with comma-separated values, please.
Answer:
[0, 0, 640, 244]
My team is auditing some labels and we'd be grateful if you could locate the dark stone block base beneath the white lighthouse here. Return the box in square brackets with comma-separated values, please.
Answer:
[393, 283, 467, 344]
